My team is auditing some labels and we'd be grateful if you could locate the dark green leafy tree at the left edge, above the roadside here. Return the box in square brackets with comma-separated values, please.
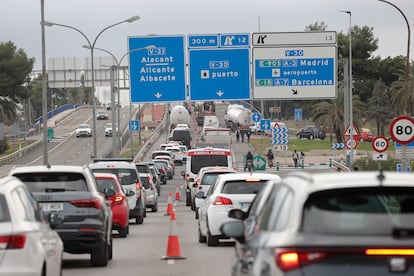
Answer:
[0, 41, 34, 123]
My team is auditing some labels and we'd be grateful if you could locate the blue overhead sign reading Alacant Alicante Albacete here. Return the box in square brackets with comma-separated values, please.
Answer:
[128, 36, 186, 103]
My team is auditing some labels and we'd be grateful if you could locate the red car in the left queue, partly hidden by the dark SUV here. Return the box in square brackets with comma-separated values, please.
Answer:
[94, 173, 129, 238]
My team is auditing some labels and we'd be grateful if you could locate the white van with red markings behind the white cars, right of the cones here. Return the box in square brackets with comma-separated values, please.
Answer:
[181, 147, 233, 206]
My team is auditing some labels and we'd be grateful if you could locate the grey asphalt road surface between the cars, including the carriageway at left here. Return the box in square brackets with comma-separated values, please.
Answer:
[3, 103, 332, 276]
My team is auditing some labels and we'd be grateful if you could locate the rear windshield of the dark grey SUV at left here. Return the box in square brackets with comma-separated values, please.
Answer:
[14, 172, 88, 192]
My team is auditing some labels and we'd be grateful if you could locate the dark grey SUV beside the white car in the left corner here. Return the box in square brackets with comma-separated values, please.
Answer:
[10, 166, 112, 266]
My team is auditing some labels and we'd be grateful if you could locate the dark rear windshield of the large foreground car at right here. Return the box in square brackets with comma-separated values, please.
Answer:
[302, 187, 414, 235]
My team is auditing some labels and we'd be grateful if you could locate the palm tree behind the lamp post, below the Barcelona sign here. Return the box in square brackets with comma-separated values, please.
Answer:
[312, 86, 366, 143]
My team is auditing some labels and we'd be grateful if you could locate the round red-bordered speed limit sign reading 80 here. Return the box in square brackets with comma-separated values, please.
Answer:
[390, 116, 414, 145]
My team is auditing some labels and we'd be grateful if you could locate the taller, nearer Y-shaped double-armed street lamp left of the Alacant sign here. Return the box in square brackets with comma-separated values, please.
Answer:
[43, 15, 140, 157]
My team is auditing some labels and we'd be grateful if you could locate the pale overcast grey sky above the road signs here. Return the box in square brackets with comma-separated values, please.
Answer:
[0, 0, 414, 70]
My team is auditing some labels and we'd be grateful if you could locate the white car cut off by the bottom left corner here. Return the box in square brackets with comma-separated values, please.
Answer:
[0, 176, 64, 276]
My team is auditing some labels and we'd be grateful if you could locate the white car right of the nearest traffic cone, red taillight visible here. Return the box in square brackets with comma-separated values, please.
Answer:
[196, 173, 281, 246]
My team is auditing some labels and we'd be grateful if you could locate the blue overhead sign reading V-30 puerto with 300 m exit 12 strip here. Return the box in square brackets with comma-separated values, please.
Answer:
[188, 34, 250, 101]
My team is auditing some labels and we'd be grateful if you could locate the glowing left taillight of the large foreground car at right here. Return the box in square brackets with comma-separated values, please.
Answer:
[275, 249, 328, 272]
